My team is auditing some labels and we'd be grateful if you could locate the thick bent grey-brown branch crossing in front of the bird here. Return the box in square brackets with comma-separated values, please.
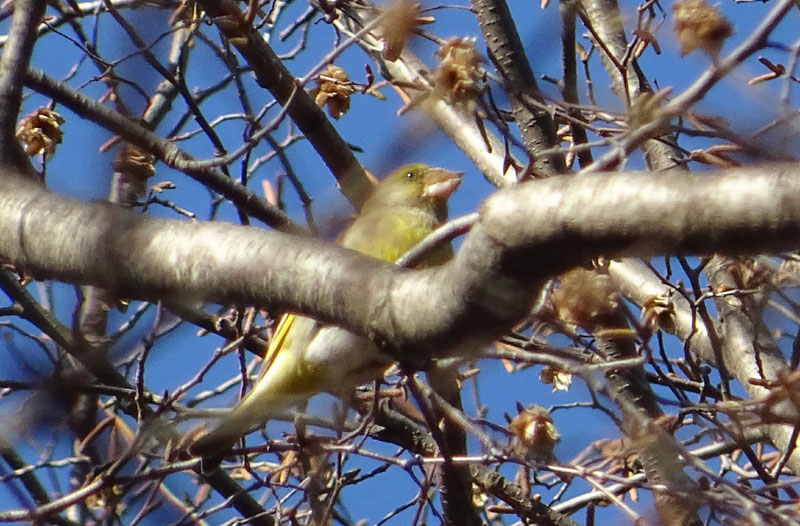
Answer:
[0, 164, 800, 370]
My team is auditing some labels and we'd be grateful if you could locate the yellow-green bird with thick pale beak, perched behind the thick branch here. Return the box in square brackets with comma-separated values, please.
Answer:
[189, 164, 462, 456]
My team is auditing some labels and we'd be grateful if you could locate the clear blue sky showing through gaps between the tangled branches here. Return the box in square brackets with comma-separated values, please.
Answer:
[0, 0, 800, 525]
